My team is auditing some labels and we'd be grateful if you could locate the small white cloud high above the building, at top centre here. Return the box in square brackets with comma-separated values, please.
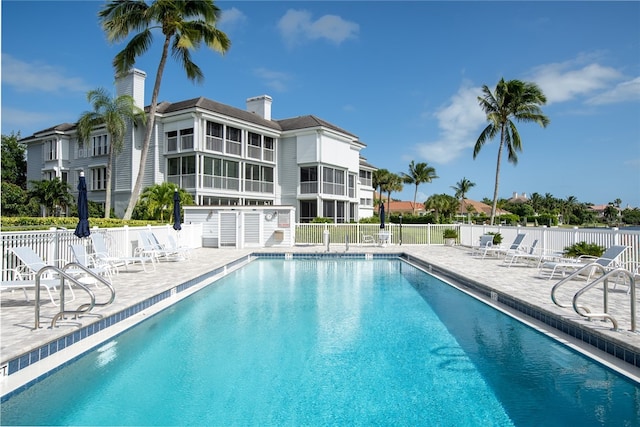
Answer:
[278, 9, 360, 46]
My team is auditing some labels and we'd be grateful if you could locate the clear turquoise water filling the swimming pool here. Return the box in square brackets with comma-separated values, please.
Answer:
[0, 259, 640, 426]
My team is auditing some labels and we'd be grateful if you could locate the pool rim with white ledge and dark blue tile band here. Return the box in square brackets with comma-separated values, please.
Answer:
[0, 250, 640, 402]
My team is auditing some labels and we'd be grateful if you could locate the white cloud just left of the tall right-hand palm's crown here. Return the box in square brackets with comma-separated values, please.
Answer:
[416, 84, 486, 163]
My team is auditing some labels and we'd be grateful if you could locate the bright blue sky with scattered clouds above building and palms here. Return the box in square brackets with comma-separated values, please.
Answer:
[1, 0, 640, 207]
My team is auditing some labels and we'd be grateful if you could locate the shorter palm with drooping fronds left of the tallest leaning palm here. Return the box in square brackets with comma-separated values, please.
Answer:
[78, 88, 145, 218]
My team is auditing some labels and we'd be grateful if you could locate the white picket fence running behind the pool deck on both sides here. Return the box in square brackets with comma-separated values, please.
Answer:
[1, 224, 640, 280]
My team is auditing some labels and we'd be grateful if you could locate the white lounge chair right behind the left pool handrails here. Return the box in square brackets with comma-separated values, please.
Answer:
[9, 246, 76, 306]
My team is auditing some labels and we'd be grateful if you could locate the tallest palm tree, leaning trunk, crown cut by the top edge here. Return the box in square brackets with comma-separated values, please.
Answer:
[98, 0, 231, 219]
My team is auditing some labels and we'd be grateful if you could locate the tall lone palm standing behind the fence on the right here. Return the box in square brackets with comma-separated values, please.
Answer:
[473, 79, 549, 225]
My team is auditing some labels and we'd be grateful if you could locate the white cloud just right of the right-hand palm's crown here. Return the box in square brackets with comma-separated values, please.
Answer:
[527, 61, 621, 104]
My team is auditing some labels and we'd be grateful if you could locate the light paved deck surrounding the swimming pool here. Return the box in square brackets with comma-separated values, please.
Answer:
[0, 245, 640, 396]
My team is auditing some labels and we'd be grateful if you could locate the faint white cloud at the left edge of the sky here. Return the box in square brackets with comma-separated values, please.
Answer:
[2, 54, 91, 93]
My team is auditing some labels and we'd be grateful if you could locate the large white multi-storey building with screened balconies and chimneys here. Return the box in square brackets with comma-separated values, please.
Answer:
[21, 70, 376, 222]
